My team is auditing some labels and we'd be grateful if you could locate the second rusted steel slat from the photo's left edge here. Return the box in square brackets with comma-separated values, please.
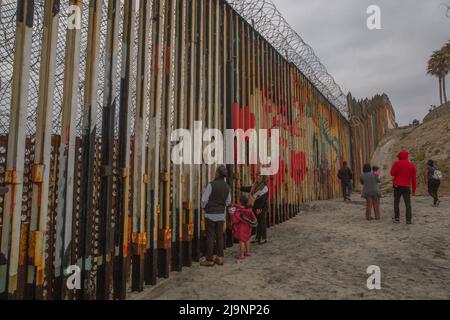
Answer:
[26, 0, 61, 299]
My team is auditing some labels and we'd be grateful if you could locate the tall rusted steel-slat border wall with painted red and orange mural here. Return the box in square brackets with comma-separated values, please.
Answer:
[0, 0, 391, 299]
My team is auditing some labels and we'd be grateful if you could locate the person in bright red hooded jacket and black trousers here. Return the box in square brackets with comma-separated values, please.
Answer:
[391, 151, 417, 224]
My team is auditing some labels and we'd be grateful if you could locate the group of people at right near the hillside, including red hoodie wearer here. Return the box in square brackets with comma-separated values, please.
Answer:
[338, 151, 443, 224]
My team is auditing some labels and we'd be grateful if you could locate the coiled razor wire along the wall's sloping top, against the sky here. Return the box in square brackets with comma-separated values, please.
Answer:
[228, 0, 348, 118]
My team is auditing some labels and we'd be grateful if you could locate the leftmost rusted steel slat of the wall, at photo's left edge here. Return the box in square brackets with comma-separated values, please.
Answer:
[0, 0, 35, 299]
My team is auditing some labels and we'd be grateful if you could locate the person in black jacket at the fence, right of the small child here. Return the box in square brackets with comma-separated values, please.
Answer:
[241, 171, 269, 244]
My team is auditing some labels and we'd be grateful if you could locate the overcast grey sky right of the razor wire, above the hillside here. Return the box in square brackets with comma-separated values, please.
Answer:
[273, 0, 450, 125]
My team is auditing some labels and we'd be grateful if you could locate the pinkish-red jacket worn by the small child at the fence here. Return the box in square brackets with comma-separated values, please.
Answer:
[230, 205, 257, 242]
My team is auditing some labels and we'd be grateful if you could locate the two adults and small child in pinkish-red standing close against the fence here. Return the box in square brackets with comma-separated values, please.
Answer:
[200, 166, 269, 267]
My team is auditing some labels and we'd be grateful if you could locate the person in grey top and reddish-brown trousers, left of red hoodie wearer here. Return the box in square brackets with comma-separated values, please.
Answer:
[361, 164, 381, 221]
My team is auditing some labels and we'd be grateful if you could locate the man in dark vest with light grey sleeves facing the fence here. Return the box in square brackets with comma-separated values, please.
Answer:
[201, 166, 231, 267]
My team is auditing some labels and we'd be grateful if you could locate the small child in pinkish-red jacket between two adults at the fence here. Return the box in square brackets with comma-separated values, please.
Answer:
[230, 195, 258, 260]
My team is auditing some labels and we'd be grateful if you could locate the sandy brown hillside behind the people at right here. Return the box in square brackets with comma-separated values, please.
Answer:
[372, 113, 450, 195]
